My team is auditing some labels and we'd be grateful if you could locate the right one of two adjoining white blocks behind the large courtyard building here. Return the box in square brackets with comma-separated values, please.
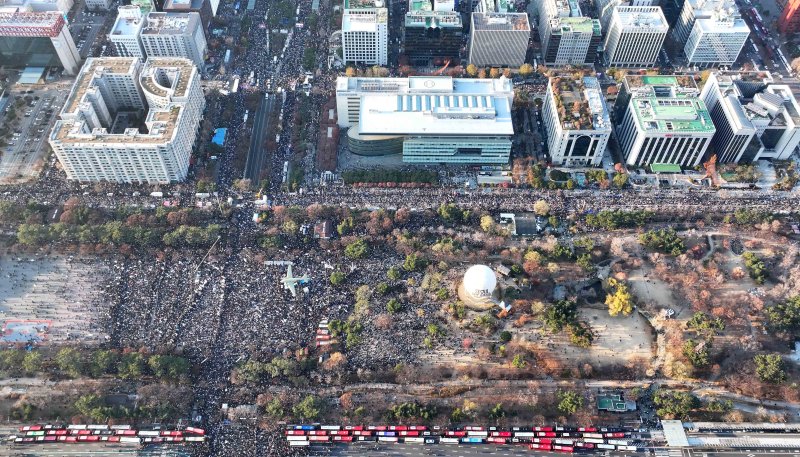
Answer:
[139, 13, 207, 68]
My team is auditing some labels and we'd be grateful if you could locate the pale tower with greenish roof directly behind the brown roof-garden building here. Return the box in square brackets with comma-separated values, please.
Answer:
[539, 0, 603, 65]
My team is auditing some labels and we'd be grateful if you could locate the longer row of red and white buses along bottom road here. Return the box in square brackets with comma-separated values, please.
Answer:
[284, 424, 640, 453]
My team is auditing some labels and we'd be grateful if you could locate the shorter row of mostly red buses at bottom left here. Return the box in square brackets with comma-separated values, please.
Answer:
[8, 424, 206, 444]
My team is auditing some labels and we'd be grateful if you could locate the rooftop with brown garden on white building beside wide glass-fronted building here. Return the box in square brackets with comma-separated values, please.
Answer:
[550, 74, 611, 131]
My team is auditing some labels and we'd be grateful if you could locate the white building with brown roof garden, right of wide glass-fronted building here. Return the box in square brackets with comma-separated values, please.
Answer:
[542, 74, 611, 166]
